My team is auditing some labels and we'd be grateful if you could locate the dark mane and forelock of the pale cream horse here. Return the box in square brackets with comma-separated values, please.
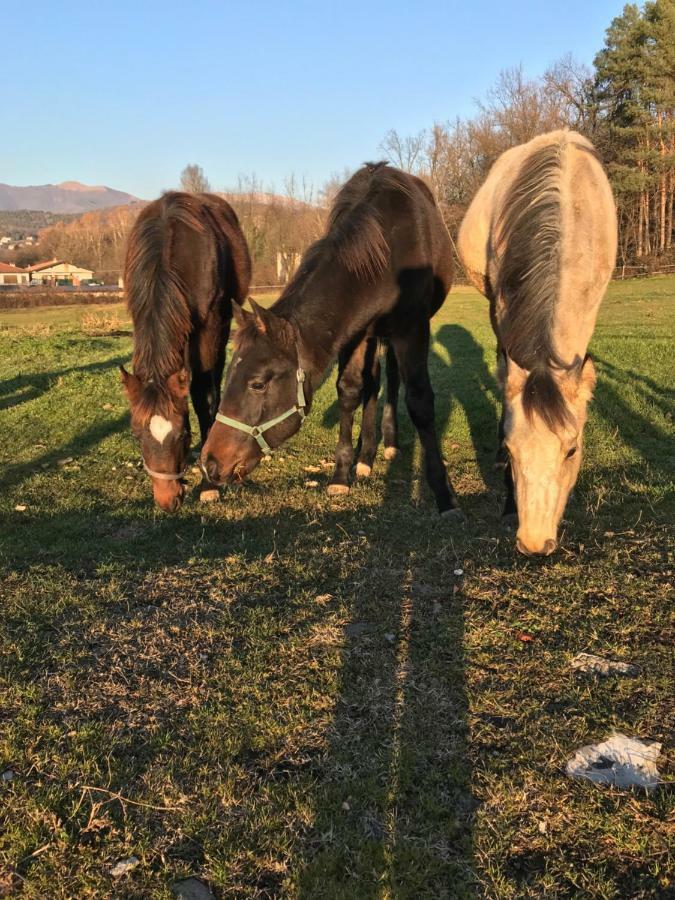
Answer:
[496, 139, 569, 429]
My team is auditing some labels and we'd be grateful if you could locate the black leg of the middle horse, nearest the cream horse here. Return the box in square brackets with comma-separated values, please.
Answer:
[392, 320, 459, 514]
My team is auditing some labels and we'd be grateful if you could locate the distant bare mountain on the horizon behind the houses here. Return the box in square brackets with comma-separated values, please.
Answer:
[0, 181, 138, 214]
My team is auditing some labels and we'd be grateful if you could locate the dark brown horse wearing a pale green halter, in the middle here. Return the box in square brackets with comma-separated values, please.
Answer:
[202, 163, 458, 513]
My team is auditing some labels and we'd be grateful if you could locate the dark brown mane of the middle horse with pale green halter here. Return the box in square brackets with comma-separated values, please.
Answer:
[284, 162, 412, 295]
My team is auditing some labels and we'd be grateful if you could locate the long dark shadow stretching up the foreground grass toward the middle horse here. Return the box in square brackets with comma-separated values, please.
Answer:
[298, 432, 477, 888]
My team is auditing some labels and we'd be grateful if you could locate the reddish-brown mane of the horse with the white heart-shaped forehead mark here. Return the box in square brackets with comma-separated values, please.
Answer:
[124, 191, 205, 382]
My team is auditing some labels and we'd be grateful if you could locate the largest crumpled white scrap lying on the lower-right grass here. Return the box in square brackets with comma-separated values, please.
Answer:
[565, 731, 661, 790]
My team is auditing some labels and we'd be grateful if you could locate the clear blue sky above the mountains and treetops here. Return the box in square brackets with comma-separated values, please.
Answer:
[0, 0, 623, 198]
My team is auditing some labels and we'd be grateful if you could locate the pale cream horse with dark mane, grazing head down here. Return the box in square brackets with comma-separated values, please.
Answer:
[458, 131, 617, 554]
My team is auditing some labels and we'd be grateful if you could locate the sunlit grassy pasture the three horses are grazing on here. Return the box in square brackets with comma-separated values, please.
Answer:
[0, 277, 675, 900]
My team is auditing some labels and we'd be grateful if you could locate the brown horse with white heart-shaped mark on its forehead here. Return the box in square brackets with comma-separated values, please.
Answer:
[120, 192, 251, 512]
